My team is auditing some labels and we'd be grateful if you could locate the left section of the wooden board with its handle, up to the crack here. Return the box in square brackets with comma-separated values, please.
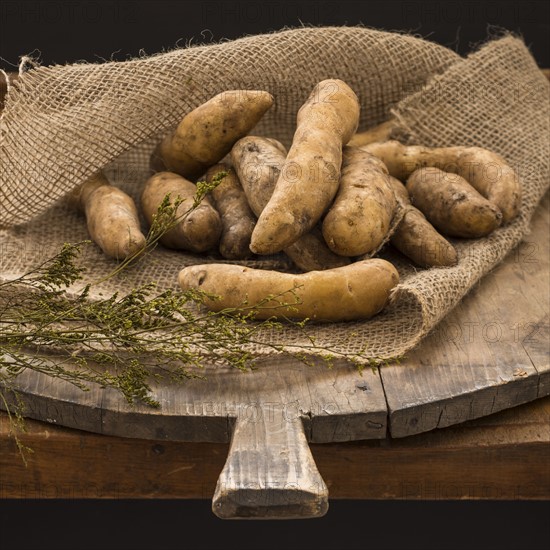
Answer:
[0, 357, 387, 519]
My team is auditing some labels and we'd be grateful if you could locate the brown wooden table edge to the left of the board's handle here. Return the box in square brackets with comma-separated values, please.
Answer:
[0, 413, 228, 499]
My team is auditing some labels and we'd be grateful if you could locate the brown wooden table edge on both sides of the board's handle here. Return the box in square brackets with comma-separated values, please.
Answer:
[0, 398, 550, 500]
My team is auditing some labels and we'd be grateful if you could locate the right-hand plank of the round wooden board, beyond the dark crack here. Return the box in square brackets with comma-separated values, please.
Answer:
[380, 193, 550, 437]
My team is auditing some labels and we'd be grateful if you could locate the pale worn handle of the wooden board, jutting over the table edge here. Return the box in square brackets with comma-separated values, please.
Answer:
[212, 409, 328, 519]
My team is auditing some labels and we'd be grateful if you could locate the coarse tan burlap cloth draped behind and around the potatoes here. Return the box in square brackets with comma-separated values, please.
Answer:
[0, 27, 550, 366]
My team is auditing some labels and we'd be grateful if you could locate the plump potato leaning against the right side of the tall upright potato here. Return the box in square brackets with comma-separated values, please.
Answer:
[323, 147, 397, 256]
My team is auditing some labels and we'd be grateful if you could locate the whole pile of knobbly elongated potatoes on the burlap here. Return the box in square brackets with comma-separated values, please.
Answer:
[72, 80, 521, 321]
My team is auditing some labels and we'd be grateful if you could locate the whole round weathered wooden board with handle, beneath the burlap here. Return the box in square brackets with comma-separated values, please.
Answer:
[2, 194, 550, 519]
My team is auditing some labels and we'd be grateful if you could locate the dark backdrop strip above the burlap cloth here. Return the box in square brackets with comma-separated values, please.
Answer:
[0, 0, 550, 70]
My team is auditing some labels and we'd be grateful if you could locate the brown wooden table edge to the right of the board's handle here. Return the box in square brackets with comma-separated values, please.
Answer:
[312, 398, 550, 500]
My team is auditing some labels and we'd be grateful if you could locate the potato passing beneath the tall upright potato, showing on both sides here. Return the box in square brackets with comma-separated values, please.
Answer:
[231, 136, 350, 271]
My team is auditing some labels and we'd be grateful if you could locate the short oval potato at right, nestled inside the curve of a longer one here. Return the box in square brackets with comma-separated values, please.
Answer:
[407, 167, 502, 239]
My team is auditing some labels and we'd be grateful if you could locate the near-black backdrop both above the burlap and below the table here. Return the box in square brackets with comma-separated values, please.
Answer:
[0, 0, 550, 550]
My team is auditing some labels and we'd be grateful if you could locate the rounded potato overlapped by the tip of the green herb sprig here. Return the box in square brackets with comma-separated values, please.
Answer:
[141, 172, 222, 252]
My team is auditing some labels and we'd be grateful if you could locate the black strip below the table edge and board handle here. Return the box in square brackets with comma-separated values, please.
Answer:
[0, 500, 550, 550]
